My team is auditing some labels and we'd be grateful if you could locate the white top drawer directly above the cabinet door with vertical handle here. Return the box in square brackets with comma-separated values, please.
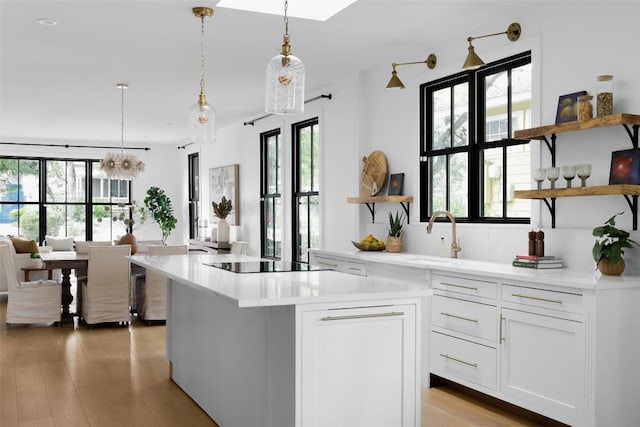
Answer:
[502, 285, 584, 313]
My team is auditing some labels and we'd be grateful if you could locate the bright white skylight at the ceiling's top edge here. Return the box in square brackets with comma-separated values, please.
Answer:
[218, 0, 356, 21]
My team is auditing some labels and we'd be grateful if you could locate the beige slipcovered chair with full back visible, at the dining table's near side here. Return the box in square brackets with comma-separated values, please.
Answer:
[78, 245, 131, 325]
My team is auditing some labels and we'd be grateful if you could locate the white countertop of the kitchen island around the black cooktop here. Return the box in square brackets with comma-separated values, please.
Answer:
[130, 254, 431, 307]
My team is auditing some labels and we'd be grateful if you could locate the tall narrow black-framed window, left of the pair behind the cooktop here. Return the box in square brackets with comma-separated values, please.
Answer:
[260, 129, 283, 259]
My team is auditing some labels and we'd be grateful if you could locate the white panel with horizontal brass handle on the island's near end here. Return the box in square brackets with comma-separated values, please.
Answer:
[299, 305, 420, 427]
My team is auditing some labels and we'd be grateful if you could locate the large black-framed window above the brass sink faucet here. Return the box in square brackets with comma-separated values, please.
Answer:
[420, 52, 532, 222]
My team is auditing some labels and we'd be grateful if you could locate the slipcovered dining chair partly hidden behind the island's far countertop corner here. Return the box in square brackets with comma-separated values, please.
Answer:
[136, 245, 188, 322]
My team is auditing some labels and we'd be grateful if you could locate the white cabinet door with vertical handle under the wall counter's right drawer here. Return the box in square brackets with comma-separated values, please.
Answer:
[500, 309, 586, 424]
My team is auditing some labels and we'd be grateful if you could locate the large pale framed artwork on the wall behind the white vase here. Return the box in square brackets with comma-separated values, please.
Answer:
[207, 165, 240, 225]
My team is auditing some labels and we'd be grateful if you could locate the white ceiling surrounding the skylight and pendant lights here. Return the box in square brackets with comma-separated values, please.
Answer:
[0, 0, 522, 151]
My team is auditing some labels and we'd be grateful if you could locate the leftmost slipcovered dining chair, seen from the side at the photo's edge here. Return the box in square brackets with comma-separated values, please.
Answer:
[0, 244, 62, 324]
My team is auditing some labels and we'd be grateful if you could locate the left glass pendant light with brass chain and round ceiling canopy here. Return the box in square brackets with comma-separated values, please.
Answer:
[189, 7, 216, 144]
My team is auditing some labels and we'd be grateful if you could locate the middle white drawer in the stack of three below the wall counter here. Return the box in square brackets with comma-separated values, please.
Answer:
[431, 295, 498, 341]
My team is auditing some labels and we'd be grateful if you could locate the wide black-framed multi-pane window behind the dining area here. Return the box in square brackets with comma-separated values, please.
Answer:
[0, 157, 131, 242]
